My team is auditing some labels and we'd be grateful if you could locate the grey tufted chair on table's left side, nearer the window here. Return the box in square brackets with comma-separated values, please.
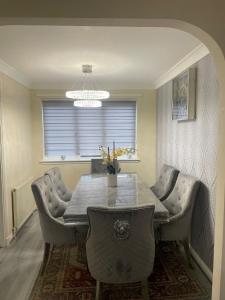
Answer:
[45, 167, 72, 202]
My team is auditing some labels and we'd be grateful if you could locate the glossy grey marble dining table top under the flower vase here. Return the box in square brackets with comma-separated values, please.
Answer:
[63, 173, 169, 222]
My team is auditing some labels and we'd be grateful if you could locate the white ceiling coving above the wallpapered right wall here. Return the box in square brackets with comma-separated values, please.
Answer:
[153, 44, 209, 89]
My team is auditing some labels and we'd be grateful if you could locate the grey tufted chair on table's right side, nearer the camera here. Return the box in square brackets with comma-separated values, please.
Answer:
[160, 173, 200, 266]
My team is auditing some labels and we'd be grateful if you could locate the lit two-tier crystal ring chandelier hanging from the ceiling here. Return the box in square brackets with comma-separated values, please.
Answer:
[66, 65, 110, 107]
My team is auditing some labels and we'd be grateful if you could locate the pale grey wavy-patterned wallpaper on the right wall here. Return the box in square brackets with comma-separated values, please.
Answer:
[156, 55, 218, 270]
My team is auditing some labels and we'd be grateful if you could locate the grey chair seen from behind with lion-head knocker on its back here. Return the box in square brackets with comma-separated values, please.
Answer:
[86, 206, 155, 299]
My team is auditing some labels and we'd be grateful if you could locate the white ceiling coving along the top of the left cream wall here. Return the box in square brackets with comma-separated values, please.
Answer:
[0, 58, 31, 88]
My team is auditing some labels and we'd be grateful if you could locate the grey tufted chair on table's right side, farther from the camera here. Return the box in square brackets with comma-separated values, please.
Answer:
[151, 164, 179, 201]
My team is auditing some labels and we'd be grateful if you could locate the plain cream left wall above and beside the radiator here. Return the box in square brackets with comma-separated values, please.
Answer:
[0, 74, 33, 242]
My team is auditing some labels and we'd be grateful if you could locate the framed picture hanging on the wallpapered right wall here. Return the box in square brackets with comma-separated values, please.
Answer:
[172, 68, 196, 121]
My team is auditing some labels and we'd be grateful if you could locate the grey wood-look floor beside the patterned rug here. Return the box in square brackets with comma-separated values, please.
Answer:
[0, 212, 211, 300]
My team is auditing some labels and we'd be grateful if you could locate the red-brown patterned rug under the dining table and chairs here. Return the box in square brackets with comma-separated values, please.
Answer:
[30, 243, 211, 300]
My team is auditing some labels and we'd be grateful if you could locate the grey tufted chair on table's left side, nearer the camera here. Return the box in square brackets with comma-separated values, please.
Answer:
[31, 175, 75, 245]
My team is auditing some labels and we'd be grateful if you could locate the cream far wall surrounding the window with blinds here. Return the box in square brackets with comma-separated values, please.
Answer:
[32, 91, 155, 189]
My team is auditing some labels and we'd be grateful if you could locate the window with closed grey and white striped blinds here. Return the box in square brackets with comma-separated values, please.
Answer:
[43, 100, 136, 159]
